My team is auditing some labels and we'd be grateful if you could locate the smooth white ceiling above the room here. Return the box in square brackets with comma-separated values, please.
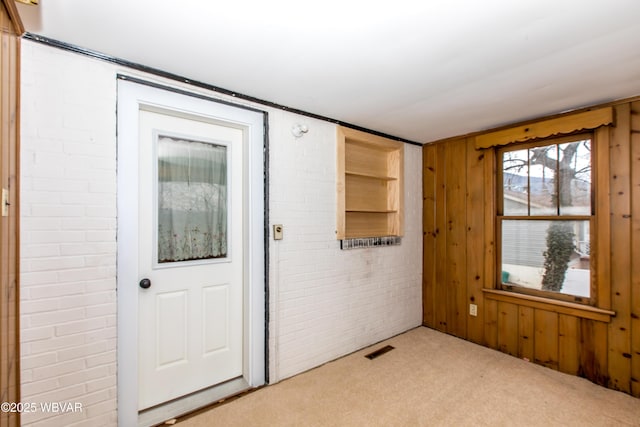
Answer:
[12, 0, 640, 142]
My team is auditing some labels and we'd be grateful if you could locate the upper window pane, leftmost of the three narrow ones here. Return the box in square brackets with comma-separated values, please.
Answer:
[502, 150, 529, 215]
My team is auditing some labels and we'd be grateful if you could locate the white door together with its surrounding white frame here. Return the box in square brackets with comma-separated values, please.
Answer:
[117, 80, 266, 426]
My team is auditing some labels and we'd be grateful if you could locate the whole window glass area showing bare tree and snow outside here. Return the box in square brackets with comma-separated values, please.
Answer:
[498, 135, 592, 298]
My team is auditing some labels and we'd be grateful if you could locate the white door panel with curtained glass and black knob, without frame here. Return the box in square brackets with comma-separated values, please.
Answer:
[138, 110, 245, 410]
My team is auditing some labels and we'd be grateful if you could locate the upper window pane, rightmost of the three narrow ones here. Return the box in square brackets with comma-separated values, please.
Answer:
[558, 140, 591, 215]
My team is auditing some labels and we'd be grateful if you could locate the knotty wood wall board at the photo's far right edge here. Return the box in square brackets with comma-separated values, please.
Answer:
[630, 101, 640, 397]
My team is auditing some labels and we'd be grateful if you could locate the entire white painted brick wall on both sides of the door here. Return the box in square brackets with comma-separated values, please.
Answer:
[21, 41, 422, 427]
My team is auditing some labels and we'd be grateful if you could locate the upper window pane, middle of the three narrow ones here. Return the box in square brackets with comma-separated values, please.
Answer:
[529, 144, 558, 215]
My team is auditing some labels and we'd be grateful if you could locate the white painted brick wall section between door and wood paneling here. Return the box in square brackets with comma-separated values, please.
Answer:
[269, 108, 422, 380]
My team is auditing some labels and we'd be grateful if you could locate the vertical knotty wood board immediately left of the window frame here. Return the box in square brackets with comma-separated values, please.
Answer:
[465, 139, 485, 343]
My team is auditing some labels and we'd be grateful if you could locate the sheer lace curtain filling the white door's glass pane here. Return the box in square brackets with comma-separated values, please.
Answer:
[158, 135, 227, 263]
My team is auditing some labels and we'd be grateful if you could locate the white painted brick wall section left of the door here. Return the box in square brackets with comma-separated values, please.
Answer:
[20, 42, 116, 426]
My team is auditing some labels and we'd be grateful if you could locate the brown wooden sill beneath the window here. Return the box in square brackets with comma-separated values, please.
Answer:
[482, 289, 616, 323]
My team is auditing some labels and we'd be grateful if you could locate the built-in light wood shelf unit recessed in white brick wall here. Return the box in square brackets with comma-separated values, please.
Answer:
[337, 127, 404, 239]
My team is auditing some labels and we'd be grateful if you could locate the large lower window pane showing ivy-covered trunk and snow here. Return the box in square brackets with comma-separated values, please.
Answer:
[501, 220, 591, 297]
